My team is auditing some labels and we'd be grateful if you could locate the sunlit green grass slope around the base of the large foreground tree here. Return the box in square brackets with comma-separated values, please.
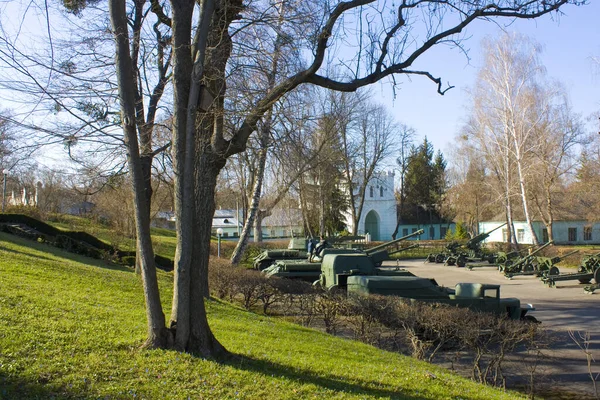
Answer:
[0, 233, 519, 399]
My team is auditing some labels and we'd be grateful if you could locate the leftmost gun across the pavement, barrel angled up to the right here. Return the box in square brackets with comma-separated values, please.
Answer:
[427, 223, 506, 267]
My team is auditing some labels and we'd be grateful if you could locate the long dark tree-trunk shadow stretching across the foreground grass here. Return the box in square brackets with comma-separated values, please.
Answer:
[221, 354, 434, 400]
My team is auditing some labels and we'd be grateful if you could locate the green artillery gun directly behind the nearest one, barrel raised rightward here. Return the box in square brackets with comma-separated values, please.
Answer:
[262, 229, 423, 282]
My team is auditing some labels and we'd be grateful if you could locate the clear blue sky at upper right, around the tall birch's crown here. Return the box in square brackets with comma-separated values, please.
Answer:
[373, 0, 600, 156]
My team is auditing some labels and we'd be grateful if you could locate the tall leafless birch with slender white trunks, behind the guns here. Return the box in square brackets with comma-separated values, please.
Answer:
[465, 34, 558, 244]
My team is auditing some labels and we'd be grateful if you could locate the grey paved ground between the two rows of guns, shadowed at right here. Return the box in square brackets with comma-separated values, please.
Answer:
[384, 260, 600, 399]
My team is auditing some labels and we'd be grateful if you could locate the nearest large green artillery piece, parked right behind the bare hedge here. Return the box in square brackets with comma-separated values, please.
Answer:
[318, 254, 534, 320]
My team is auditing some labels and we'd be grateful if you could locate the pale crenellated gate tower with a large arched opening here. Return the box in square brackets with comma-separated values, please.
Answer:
[344, 172, 397, 241]
